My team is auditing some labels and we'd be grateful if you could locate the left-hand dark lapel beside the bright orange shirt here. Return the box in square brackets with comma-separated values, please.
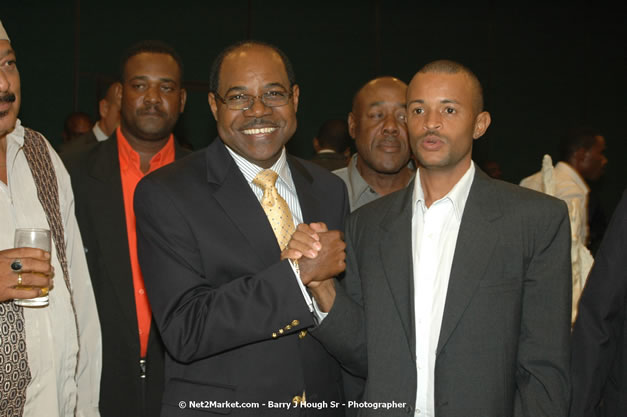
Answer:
[88, 135, 138, 335]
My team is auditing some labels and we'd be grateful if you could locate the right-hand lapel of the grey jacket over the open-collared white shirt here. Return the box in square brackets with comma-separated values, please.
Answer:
[436, 169, 501, 355]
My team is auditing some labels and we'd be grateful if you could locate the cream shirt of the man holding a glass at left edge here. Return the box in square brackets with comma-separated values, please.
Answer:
[0, 120, 102, 417]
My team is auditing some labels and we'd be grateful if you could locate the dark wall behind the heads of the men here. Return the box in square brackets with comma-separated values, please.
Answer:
[0, 0, 627, 215]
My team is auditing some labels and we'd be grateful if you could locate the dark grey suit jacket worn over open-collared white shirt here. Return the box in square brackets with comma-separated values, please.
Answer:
[312, 169, 571, 417]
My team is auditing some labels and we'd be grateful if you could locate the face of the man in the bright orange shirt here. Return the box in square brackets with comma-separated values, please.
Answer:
[118, 52, 186, 141]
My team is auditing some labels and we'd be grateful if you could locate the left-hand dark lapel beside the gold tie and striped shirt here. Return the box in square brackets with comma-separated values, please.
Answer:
[206, 138, 281, 265]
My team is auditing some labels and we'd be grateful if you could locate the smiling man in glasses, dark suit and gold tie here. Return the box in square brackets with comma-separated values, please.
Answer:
[135, 42, 348, 417]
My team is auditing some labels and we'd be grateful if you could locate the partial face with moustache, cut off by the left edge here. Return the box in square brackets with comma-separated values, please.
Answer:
[0, 40, 20, 139]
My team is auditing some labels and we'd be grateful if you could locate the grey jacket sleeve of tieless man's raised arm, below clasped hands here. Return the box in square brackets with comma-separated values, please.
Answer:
[311, 211, 368, 378]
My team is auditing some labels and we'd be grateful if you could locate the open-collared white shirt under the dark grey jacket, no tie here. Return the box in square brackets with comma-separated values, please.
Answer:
[411, 162, 475, 417]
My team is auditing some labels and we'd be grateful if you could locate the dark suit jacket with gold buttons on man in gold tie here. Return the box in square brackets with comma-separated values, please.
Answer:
[135, 140, 348, 416]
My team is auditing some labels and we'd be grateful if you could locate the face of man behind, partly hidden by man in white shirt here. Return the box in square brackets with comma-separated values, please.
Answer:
[348, 77, 410, 175]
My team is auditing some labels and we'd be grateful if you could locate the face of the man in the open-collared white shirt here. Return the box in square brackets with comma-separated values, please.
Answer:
[407, 71, 490, 178]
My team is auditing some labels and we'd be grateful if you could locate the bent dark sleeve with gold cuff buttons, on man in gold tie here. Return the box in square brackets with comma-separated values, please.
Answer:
[135, 177, 314, 363]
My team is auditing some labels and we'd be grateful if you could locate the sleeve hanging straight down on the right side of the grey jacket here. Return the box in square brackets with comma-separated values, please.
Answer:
[514, 202, 572, 417]
